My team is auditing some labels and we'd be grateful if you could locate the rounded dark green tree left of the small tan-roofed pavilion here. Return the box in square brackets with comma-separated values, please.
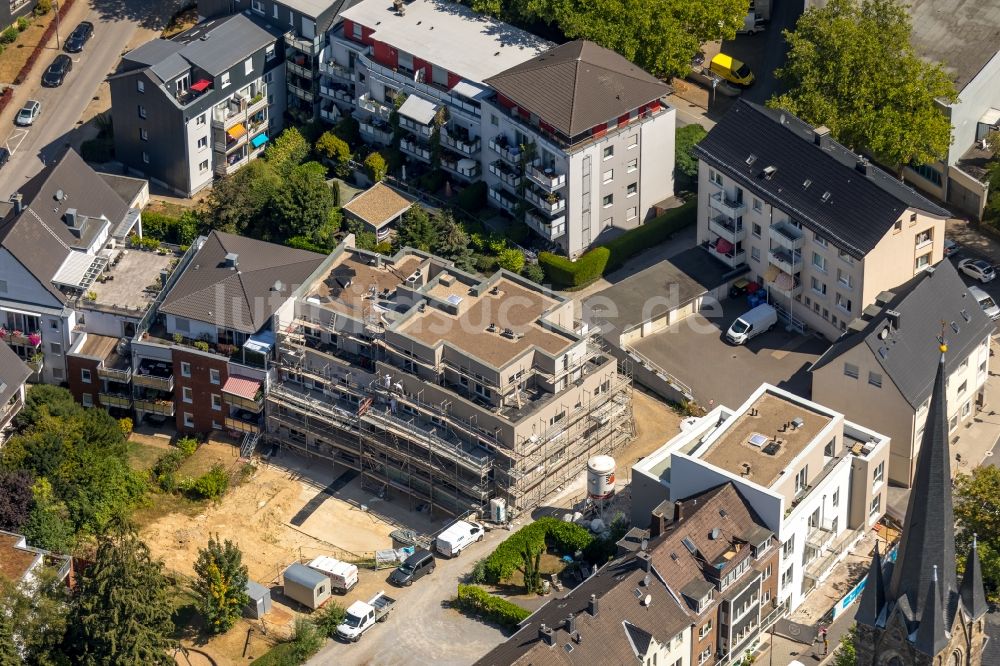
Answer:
[268, 162, 333, 241]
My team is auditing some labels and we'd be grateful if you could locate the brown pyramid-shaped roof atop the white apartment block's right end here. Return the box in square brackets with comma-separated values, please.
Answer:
[485, 40, 669, 137]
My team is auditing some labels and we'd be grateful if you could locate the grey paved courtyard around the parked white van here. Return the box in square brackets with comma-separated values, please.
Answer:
[633, 298, 828, 409]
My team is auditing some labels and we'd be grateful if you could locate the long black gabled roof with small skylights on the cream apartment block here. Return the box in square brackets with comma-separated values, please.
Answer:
[695, 100, 950, 259]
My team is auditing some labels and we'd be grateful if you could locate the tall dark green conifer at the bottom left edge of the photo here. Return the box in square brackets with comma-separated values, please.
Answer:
[64, 519, 174, 666]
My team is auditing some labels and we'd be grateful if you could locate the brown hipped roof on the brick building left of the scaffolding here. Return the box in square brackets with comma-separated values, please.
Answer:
[160, 231, 325, 333]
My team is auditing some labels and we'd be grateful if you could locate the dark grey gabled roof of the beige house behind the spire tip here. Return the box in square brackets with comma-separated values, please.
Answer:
[810, 260, 994, 409]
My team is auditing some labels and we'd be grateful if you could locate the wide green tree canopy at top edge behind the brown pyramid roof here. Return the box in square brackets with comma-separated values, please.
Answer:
[472, 0, 750, 77]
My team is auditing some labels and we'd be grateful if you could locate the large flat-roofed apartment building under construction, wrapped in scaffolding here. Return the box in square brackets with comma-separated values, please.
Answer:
[266, 241, 633, 515]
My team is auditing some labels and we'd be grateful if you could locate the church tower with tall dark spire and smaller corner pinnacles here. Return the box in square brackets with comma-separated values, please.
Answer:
[855, 343, 987, 666]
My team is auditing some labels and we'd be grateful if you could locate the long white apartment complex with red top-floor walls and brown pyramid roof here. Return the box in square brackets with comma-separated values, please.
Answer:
[320, 0, 675, 258]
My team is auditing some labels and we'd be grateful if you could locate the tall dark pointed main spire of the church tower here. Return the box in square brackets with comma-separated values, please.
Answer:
[889, 342, 958, 626]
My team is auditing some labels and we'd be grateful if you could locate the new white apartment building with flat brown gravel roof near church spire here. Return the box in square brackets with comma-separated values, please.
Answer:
[632, 384, 889, 612]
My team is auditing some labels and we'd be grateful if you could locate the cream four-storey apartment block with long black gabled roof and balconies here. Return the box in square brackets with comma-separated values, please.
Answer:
[695, 101, 949, 340]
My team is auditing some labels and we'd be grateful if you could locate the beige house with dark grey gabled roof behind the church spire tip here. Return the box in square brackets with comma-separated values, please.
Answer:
[810, 261, 994, 486]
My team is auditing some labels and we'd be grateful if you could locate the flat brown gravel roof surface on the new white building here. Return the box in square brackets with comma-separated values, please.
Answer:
[700, 391, 833, 487]
